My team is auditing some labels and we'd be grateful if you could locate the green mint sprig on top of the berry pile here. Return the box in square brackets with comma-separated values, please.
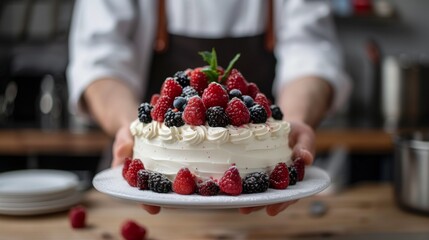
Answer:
[198, 48, 240, 83]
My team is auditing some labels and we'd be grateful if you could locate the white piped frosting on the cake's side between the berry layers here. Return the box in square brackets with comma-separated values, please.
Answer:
[130, 118, 291, 180]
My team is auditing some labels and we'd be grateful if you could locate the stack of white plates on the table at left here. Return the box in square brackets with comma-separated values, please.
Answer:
[0, 169, 83, 215]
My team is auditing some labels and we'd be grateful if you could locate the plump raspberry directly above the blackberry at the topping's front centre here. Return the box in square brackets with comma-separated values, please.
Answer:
[201, 82, 229, 108]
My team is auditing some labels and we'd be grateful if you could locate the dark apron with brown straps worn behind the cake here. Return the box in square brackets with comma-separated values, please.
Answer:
[144, 1, 276, 101]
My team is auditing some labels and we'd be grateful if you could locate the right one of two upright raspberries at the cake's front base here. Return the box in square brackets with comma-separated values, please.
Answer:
[219, 166, 243, 196]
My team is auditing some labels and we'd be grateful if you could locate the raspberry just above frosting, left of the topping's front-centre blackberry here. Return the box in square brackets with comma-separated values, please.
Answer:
[182, 96, 206, 126]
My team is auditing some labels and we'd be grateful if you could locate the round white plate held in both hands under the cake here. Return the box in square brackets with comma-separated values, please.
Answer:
[92, 166, 330, 209]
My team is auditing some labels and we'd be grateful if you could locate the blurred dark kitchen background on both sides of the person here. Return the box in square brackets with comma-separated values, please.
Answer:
[0, 0, 429, 190]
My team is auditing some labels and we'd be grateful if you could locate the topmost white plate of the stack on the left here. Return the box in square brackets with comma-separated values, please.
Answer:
[0, 169, 79, 199]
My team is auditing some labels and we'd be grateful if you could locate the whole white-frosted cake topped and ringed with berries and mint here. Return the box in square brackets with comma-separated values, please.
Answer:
[123, 50, 304, 195]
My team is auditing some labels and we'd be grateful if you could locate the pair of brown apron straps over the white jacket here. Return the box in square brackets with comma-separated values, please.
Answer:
[155, 0, 275, 53]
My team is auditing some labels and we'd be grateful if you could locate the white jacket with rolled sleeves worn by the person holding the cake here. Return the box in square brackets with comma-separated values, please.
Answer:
[67, 0, 350, 116]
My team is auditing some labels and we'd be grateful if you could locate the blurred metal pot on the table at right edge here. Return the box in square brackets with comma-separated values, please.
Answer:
[394, 132, 429, 214]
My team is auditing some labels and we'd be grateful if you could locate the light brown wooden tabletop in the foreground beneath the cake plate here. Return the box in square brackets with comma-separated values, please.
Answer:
[0, 184, 429, 240]
